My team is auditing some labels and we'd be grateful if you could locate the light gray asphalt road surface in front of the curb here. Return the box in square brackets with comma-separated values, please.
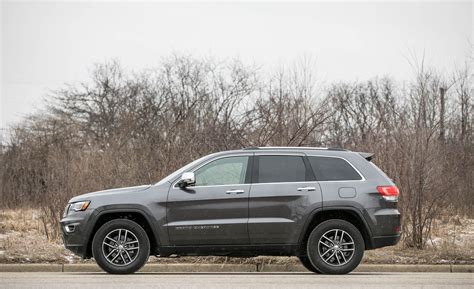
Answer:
[0, 273, 474, 289]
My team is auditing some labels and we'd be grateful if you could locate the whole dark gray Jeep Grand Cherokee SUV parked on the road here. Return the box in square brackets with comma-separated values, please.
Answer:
[61, 147, 400, 274]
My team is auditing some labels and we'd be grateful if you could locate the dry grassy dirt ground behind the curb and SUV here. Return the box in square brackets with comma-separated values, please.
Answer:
[0, 210, 474, 264]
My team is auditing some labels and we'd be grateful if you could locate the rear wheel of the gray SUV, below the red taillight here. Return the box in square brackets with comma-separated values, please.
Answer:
[306, 219, 365, 274]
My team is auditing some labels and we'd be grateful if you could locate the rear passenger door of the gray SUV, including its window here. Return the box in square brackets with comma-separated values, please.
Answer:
[249, 153, 322, 244]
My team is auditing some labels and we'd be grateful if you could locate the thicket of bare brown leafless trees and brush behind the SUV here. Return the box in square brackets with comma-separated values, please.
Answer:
[0, 55, 474, 243]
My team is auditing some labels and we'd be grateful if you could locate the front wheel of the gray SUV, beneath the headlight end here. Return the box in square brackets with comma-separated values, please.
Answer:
[92, 219, 150, 274]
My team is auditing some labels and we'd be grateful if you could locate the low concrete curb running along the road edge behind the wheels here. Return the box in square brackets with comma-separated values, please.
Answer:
[0, 263, 474, 273]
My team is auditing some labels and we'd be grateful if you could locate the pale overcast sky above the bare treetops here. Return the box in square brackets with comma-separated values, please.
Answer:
[0, 0, 473, 127]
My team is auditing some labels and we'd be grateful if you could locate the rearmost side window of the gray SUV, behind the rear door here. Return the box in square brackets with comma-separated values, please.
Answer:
[308, 156, 362, 181]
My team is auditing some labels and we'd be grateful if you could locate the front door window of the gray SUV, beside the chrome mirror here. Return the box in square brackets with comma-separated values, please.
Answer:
[194, 157, 248, 186]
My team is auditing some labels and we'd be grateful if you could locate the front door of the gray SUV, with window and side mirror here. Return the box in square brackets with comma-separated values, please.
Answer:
[166, 154, 251, 245]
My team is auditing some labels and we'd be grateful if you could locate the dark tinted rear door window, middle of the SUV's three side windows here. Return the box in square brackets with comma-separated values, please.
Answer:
[258, 156, 306, 183]
